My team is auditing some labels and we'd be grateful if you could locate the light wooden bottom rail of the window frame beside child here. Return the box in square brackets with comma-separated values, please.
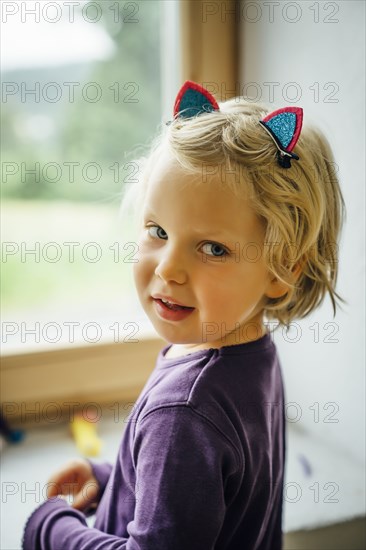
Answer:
[0, 325, 167, 427]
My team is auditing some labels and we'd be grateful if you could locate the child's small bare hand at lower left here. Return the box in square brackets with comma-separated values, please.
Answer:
[47, 458, 99, 512]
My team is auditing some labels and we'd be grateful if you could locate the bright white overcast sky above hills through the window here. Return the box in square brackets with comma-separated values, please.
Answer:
[1, 0, 115, 71]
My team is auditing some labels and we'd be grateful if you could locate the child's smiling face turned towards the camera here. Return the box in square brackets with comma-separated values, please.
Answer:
[133, 149, 280, 351]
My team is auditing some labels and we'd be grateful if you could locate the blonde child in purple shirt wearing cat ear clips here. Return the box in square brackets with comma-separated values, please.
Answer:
[23, 81, 344, 550]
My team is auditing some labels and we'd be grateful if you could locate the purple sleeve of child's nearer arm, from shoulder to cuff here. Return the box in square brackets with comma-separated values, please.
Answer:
[23, 405, 237, 550]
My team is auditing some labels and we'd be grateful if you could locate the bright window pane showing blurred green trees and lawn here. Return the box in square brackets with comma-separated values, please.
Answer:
[1, 0, 162, 352]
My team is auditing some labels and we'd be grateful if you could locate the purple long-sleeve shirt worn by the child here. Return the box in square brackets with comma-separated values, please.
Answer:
[23, 333, 285, 550]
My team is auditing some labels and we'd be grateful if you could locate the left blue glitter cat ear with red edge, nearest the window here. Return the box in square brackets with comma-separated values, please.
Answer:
[173, 80, 219, 122]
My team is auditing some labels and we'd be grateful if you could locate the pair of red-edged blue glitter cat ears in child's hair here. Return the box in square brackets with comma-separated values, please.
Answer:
[166, 80, 303, 168]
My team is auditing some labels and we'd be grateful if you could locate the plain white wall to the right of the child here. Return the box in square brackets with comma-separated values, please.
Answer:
[238, 0, 365, 466]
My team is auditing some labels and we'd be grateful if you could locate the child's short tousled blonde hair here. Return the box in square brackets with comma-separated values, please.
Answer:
[122, 97, 346, 328]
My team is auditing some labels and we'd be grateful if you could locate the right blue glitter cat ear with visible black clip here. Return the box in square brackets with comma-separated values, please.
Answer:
[259, 107, 303, 168]
